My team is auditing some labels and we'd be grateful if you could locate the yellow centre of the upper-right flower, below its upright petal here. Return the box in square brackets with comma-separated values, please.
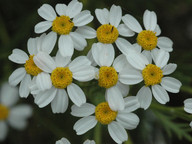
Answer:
[137, 30, 157, 50]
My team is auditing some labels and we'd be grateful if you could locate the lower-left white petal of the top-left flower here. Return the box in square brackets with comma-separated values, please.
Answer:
[34, 21, 52, 34]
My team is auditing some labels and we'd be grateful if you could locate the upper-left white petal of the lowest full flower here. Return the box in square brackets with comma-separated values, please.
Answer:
[71, 103, 95, 117]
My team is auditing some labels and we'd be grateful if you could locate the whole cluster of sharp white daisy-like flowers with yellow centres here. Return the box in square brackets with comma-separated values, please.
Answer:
[9, 0, 181, 144]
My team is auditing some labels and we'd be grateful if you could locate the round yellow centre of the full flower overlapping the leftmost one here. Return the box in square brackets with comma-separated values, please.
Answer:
[51, 67, 73, 89]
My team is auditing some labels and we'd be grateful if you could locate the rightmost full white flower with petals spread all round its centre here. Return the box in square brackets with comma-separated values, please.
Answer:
[124, 49, 182, 109]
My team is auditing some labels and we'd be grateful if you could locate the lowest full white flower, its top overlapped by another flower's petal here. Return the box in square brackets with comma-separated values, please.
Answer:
[71, 96, 140, 143]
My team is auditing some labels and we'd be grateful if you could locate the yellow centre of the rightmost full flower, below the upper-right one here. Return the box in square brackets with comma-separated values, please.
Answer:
[142, 64, 163, 86]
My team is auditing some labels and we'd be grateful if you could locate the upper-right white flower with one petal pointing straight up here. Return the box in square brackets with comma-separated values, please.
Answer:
[122, 10, 173, 53]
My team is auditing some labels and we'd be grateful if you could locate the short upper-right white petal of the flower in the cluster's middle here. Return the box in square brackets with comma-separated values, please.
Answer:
[113, 54, 128, 72]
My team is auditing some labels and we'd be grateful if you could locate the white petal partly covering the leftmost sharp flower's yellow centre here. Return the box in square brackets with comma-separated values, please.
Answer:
[33, 52, 56, 73]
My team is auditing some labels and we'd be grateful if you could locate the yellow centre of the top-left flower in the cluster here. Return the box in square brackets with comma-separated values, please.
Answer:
[52, 15, 74, 35]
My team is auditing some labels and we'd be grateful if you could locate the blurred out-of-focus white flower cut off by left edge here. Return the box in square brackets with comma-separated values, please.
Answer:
[0, 83, 32, 141]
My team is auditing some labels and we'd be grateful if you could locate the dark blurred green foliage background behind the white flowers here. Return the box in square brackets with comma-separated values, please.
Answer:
[0, 0, 192, 144]
